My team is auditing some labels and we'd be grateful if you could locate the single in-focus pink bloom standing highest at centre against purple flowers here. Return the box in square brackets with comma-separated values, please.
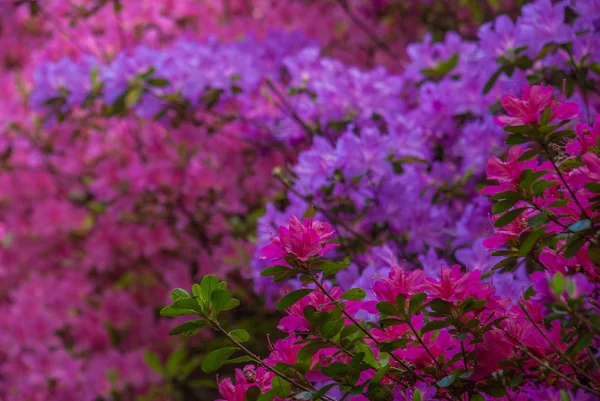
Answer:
[262, 216, 338, 261]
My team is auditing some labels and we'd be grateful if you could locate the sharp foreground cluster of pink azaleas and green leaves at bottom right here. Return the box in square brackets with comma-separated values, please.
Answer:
[166, 211, 600, 401]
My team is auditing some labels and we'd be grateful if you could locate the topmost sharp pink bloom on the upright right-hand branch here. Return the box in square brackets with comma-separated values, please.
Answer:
[494, 85, 579, 127]
